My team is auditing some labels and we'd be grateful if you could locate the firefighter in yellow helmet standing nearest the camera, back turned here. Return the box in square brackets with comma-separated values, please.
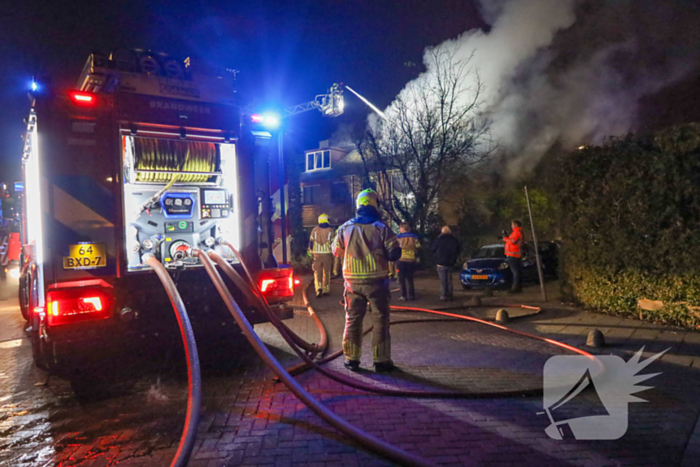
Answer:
[333, 189, 401, 371]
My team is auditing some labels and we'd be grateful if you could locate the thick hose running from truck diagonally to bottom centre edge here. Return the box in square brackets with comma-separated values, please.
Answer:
[192, 249, 430, 466]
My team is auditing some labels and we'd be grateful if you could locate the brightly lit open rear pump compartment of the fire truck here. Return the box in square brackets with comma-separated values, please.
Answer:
[122, 135, 241, 272]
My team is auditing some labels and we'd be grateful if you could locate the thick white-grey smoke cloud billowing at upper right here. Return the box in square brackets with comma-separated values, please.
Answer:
[386, 0, 700, 175]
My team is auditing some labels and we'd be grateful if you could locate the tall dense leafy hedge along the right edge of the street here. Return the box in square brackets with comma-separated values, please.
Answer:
[558, 124, 700, 327]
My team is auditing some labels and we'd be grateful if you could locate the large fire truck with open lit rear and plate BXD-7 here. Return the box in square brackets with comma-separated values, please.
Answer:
[19, 50, 293, 372]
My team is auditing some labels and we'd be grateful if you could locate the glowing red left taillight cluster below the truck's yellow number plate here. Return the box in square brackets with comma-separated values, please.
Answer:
[46, 287, 112, 326]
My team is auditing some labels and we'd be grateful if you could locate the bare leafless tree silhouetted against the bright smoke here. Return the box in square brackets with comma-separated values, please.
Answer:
[358, 48, 491, 233]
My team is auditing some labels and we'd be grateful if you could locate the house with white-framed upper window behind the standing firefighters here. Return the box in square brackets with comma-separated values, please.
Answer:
[300, 140, 363, 228]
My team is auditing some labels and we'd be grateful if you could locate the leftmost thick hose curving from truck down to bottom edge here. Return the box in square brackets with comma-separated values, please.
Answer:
[143, 253, 202, 467]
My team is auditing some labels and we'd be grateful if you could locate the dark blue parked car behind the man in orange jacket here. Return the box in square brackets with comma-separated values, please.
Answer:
[459, 242, 559, 289]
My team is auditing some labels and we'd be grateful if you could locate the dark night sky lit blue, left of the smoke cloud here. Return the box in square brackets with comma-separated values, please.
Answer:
[0, 0, 485, 181]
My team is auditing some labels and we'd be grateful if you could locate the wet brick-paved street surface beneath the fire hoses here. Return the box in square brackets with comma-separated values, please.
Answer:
[0, 276, 700, 466]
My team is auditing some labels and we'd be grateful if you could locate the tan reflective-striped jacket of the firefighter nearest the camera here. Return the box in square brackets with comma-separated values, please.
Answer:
[333, 219, 399, 281]
